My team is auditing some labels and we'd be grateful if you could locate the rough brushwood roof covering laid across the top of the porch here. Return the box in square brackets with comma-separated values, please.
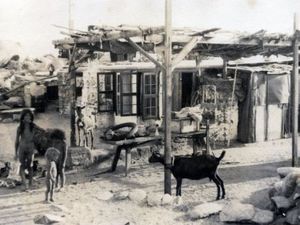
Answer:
[53, 25, 293, 60]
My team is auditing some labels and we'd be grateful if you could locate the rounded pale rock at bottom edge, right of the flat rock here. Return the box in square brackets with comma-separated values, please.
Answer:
[220, 201, 255, 222]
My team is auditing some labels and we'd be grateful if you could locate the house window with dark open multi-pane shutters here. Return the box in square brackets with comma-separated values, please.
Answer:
[98, 71, 159, 119]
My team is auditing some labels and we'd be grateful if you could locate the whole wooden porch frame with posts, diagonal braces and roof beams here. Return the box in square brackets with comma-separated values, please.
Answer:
[53, 4, 300, 194]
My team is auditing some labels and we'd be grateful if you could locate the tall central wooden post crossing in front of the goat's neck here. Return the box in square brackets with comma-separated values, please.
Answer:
[164, 0, 172, 194]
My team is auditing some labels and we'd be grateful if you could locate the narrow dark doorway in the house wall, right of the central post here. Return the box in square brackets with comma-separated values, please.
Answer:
[181, 73, 193, 108]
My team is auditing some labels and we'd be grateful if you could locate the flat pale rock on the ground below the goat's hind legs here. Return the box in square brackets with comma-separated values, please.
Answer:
[189, 202, 223, 220]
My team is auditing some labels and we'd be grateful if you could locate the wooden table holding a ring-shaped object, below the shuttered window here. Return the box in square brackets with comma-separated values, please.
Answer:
[104, 136, 163, 176]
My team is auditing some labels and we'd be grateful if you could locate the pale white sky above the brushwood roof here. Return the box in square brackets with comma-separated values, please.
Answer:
[0, 0, 300, 56]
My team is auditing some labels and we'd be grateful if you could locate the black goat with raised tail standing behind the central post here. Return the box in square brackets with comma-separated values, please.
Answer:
[149, 151, 225, 200]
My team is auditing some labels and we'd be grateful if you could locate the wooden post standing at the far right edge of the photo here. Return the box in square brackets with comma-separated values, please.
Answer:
[291, 14, 299, 167]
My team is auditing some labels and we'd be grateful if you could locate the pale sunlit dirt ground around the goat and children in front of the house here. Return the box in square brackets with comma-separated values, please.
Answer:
[0, 106, 291, 225]
